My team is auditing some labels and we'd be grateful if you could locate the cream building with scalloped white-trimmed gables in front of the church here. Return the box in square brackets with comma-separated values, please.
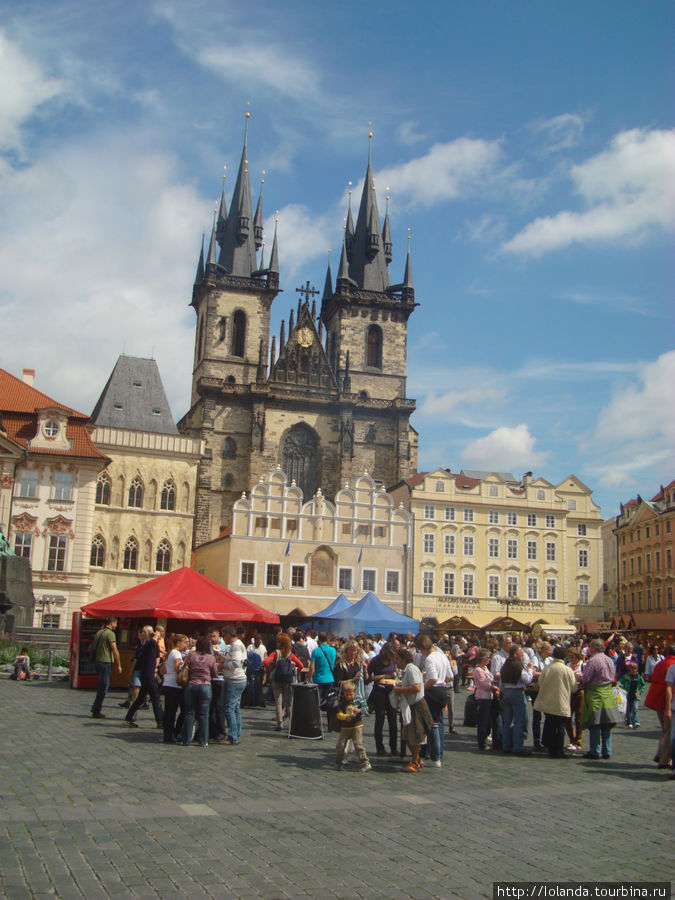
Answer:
[195, 469, 412, 616]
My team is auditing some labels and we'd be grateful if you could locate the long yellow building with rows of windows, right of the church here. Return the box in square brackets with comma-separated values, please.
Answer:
[390, 469, 602, 632]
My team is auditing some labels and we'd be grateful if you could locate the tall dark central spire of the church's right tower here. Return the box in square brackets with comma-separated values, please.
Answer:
[349, 131, 389, 291]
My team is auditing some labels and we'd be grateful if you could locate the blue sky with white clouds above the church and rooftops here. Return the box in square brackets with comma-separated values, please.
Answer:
[0, 0, 675, 517]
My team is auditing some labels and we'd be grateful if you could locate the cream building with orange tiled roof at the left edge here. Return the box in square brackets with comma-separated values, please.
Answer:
[0, 369, 109, 628]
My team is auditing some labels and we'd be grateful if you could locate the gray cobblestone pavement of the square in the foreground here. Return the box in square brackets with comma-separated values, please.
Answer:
[0, 679, 675, 900]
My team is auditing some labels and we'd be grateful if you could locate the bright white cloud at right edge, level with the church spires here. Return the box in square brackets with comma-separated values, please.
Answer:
[502, 129, 675, 257]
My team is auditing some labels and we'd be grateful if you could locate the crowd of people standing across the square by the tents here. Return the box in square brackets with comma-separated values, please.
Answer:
[91, 619, 675, 777]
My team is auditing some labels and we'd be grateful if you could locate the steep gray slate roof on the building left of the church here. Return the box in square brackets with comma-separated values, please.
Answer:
[91, 356, 178, 434]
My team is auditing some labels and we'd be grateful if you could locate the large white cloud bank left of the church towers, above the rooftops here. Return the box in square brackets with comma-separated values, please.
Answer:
[0, 132, 205, 415]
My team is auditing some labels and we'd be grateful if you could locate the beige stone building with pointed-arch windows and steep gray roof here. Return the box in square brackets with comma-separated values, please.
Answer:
[89, 356, 202, 600]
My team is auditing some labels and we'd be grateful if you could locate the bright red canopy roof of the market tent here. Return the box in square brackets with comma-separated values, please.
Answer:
[82, 566, 279, 625]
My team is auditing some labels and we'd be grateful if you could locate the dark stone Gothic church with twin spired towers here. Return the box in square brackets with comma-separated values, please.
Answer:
[178, 121, 417, 546]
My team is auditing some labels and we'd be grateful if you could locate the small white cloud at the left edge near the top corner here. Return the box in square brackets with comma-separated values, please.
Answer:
[0, 31, 64, 151]
